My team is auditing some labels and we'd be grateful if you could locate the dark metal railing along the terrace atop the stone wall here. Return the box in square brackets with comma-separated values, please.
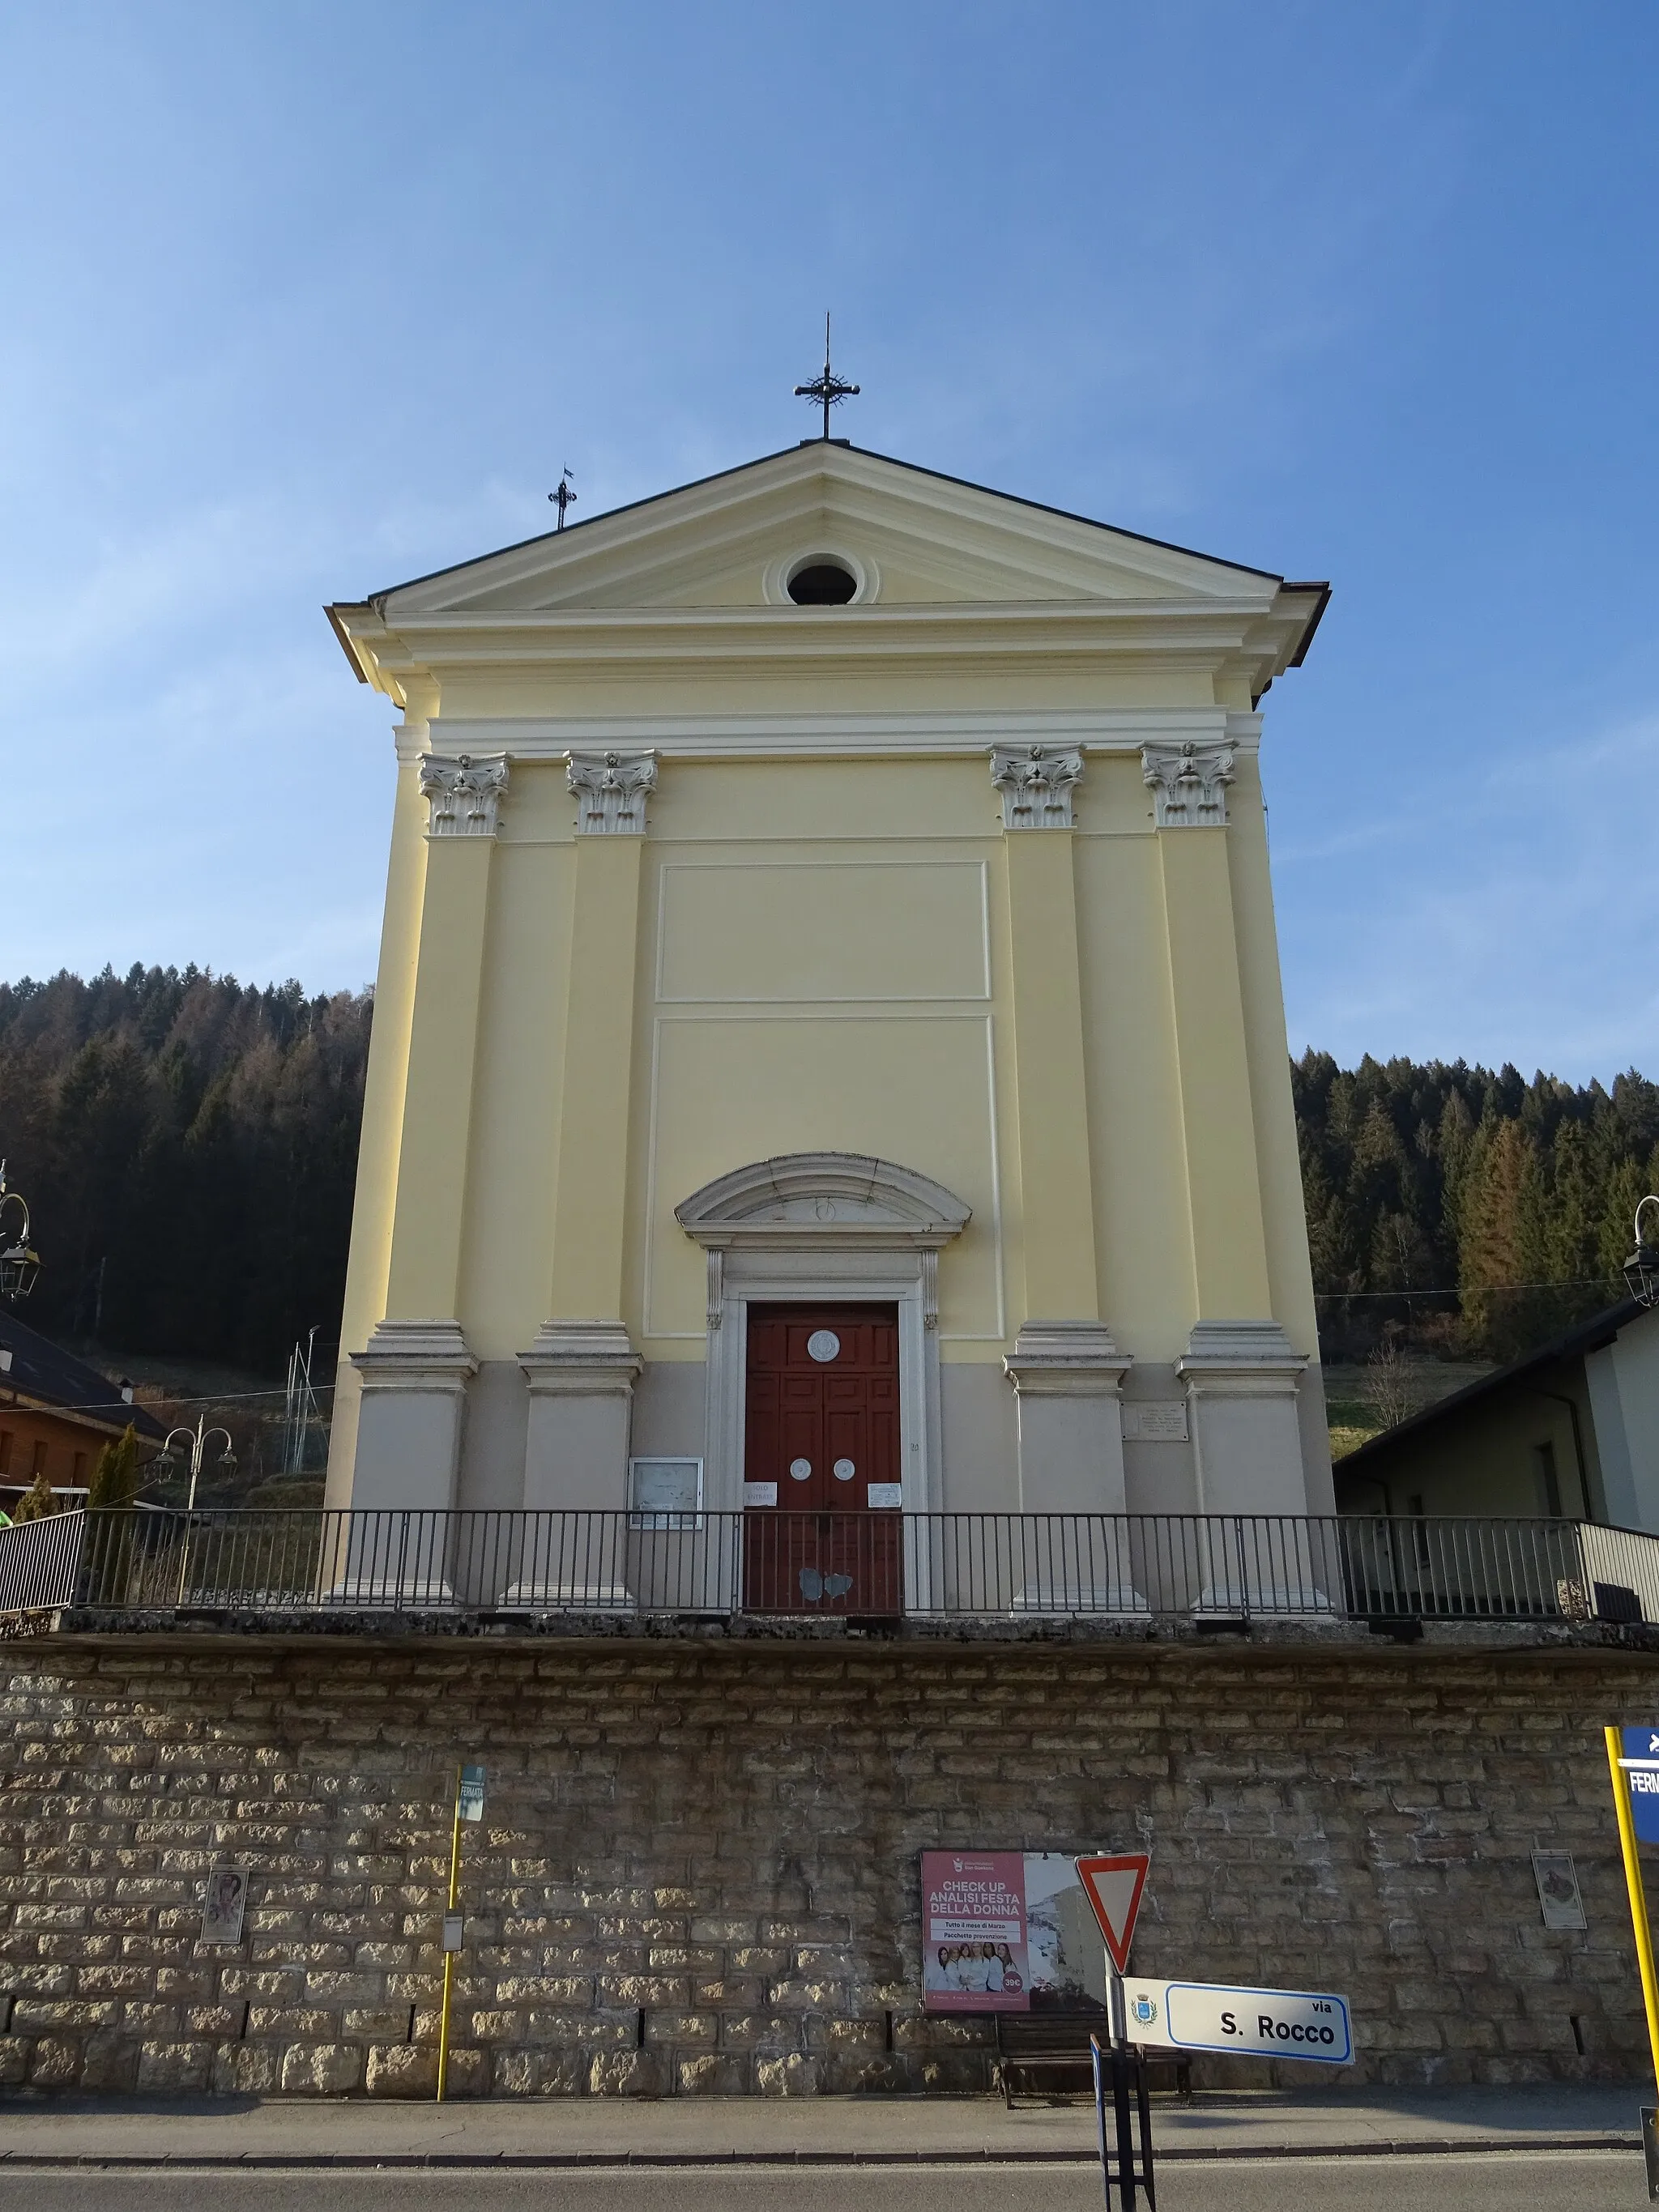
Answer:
[0, 1509, 1659, 1622]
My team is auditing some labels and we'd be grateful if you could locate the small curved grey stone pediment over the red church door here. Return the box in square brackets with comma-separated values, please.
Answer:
[675, 1153, 973, 1252]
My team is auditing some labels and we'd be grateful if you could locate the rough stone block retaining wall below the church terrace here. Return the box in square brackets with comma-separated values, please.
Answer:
[0, 1634, 1659, 2097]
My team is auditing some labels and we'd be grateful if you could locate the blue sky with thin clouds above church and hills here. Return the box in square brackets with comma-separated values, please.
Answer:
[0, 0, 1659, 1080]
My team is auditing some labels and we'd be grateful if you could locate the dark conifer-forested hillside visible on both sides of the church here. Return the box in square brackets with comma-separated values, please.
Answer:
[0, 966, 1659, 1374]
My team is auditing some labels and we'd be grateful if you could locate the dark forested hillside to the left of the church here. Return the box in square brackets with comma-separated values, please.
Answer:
[0, 966, 372, 1374]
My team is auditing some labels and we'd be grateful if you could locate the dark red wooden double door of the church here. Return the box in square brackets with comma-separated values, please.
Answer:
[744, 1305, 905, 1613]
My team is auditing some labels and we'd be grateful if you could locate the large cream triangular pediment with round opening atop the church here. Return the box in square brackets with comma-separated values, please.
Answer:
[373, 440, 1278, 624]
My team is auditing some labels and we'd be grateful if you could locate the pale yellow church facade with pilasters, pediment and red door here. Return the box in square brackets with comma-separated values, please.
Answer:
[330, 440, 1332, 1575]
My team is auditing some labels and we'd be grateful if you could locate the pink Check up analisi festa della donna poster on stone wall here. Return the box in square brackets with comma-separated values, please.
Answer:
[923, 1852, 1106, 2013]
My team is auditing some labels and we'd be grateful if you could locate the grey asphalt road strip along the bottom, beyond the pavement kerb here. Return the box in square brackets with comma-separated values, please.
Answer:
[0, 2150, 1648, 2212]
